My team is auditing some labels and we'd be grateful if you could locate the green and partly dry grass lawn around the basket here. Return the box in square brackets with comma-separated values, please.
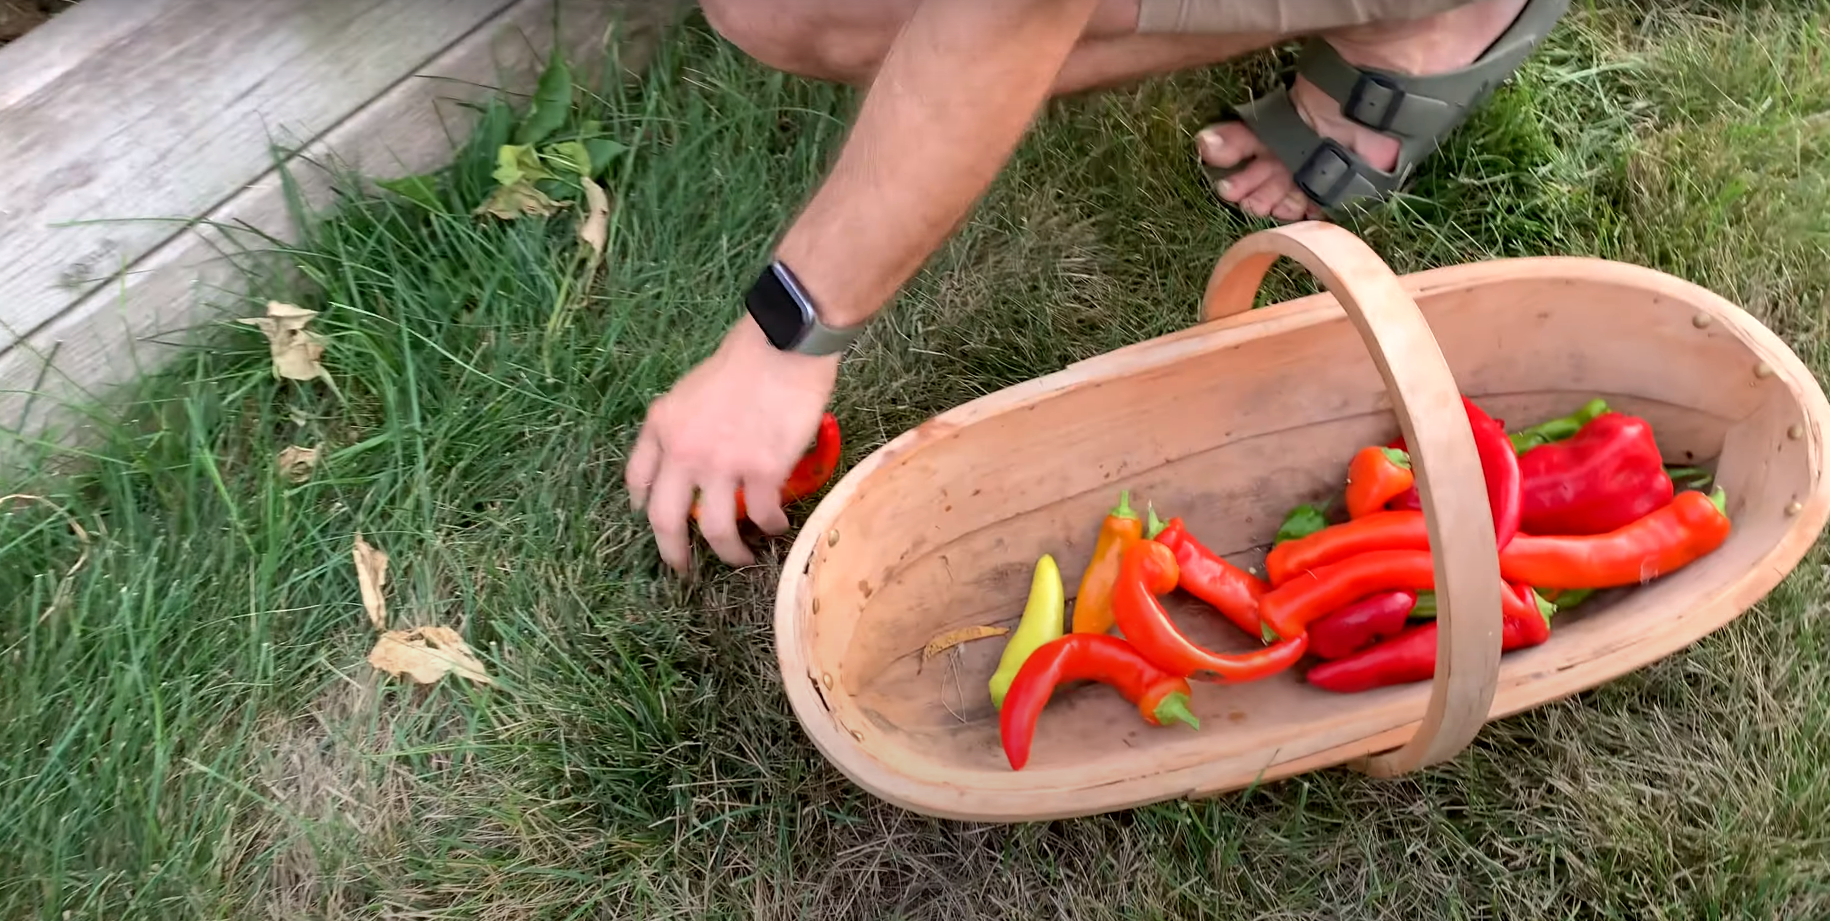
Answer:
[0, 2, 1830, 919]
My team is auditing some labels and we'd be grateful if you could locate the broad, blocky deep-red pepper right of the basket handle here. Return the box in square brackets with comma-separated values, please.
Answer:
[1519, 412, 1674, 536]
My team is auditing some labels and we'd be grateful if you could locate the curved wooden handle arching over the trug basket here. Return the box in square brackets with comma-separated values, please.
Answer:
[1202, 222, 1501, 776]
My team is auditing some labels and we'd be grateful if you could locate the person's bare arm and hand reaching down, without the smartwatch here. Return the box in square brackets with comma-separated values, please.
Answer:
[626, 0, 1098, 571]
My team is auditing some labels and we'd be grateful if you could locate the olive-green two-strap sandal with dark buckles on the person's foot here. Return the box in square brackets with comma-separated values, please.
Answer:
[1195, 0, 1570, 212]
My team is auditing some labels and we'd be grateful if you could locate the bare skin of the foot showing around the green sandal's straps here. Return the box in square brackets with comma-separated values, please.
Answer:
[1195, 0, 1526, 222]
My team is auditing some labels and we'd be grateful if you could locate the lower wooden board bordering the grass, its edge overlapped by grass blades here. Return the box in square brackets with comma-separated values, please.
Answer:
[0, 0, 613, 452]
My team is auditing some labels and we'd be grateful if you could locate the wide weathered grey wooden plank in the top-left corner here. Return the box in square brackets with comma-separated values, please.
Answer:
[0, 0, 512, 353]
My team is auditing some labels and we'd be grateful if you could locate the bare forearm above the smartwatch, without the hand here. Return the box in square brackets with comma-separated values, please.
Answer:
[778, 0, 1098, 326]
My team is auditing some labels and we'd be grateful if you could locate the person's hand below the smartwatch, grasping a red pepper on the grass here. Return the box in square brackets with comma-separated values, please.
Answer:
[624, 317, 838, 573]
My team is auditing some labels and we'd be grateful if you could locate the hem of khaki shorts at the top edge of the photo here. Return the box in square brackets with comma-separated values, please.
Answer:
[1138, 0, 1471, 35]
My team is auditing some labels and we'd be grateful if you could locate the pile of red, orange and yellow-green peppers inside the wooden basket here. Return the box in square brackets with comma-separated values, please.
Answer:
[990, 397, 1729, 771]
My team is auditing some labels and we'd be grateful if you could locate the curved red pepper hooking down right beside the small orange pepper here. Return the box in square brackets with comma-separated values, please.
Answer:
[1113, 540, 1308, 685]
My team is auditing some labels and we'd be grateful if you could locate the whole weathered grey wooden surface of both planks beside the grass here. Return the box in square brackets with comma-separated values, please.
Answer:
[0, 0, 613, 450]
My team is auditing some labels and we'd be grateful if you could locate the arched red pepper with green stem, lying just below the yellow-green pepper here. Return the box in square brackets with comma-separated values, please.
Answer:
[997, 634, 1200, 771]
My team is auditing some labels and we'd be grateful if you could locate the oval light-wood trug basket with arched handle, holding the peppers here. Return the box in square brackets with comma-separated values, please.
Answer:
[776, 223, 1830, 822]
